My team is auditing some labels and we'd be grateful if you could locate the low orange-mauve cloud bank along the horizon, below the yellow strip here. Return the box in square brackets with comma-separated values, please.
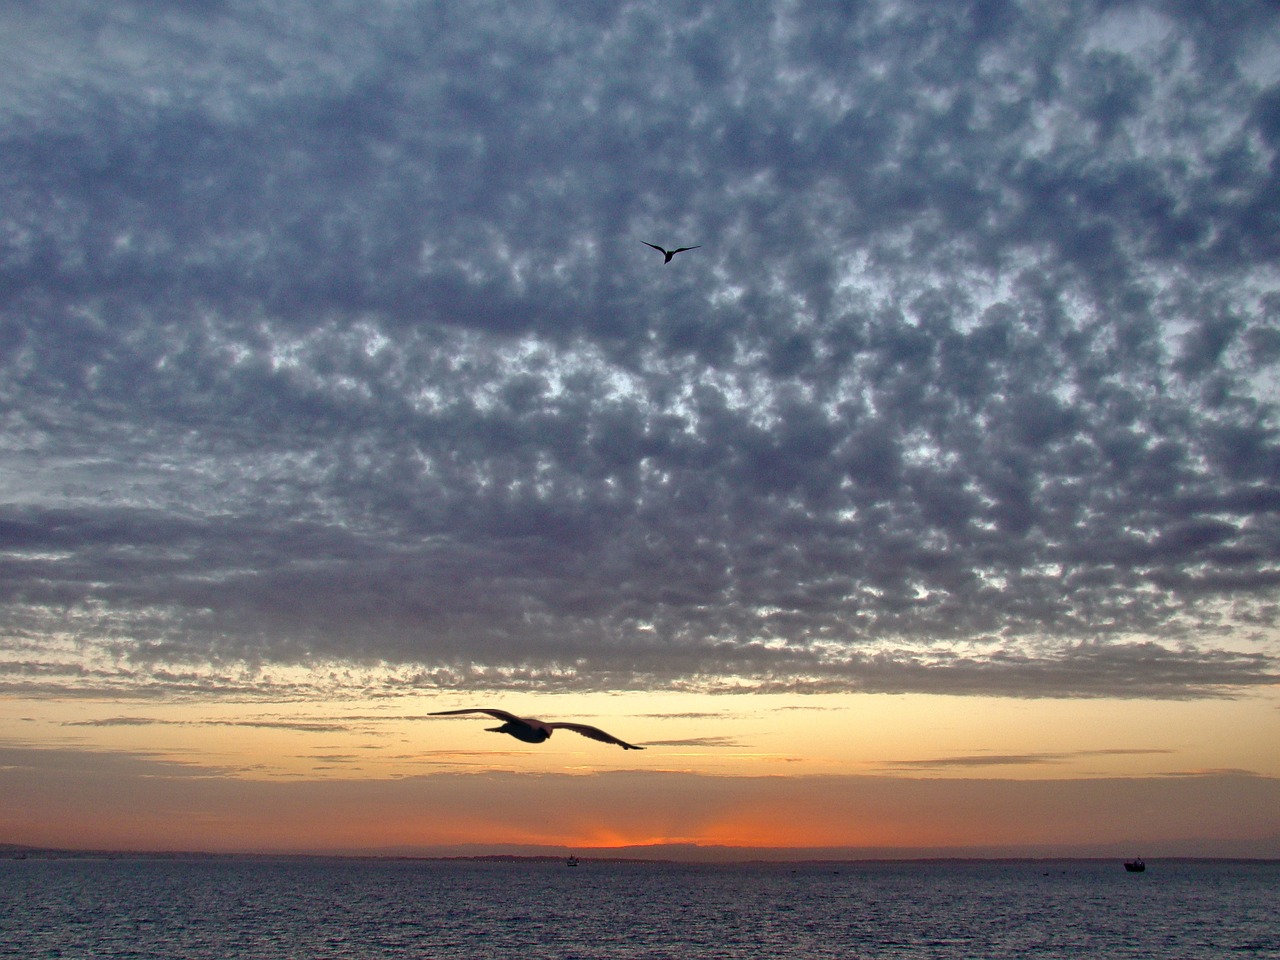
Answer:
[0, 746, 1280, 856]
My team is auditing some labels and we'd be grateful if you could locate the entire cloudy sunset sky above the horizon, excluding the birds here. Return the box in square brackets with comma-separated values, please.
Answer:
[0, 0, 1280, 856]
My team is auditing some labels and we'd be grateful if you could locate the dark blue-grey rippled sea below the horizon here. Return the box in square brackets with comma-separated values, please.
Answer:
[0, 858, 1280, 960]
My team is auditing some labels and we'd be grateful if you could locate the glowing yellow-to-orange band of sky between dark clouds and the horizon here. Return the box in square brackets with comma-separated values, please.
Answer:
[0, 695, 1280, 856]
